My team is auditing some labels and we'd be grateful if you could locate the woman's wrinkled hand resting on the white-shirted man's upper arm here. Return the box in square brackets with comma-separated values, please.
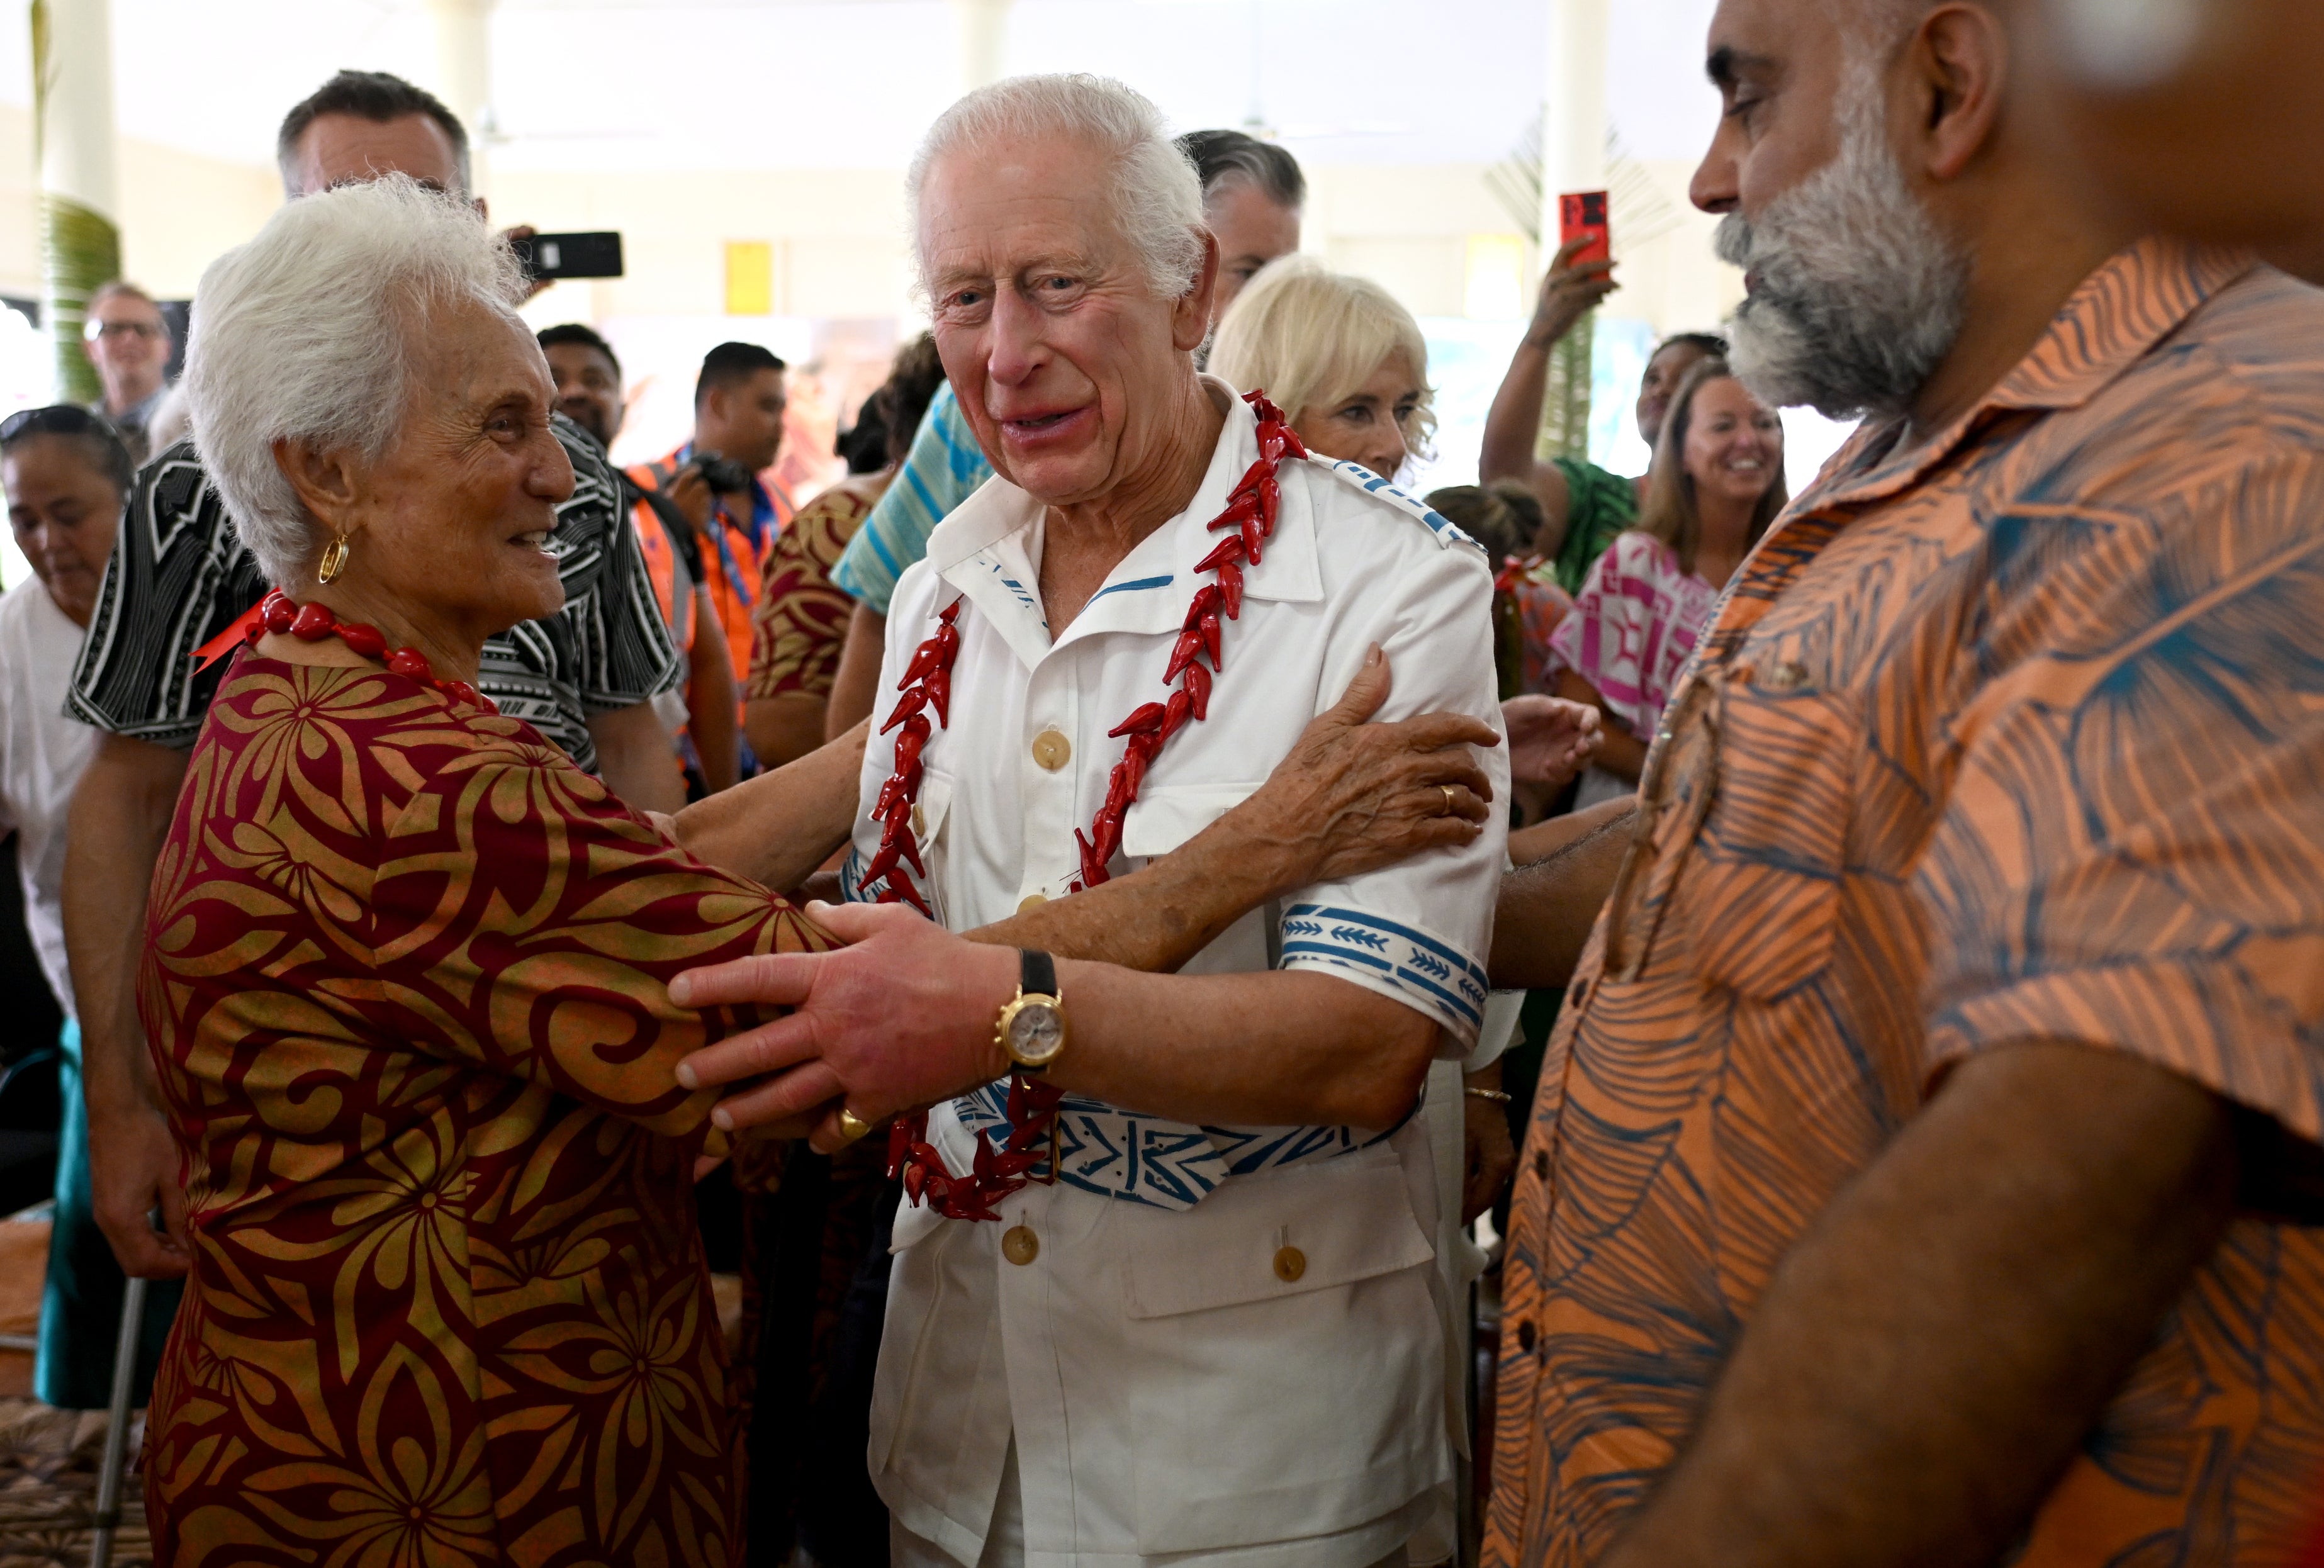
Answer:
[1218, 651, 1502, 892]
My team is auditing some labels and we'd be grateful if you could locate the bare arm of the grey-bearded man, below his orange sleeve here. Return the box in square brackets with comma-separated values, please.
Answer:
[1606, 1043, 2236, 1568]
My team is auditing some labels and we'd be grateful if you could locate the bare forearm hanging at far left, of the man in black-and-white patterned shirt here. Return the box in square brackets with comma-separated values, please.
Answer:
[65, 734, 186, 1122]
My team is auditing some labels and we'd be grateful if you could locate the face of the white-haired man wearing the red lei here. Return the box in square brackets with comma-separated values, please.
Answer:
[920, 137, 1220, 523]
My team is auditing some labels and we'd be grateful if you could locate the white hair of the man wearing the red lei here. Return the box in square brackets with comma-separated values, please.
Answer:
[904, 74, 1204, 300]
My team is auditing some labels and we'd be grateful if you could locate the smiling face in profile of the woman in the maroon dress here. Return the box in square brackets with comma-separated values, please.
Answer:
[287, 300, 574, 678]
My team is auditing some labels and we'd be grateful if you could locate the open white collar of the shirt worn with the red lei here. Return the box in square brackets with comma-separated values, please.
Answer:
[928, 376, 1322, 667]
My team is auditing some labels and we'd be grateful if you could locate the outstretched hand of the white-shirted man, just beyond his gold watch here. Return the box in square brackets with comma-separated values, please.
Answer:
[670, 904, 1018, 1152]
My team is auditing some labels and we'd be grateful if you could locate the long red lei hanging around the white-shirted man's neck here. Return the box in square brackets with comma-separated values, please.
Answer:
[858, 393, 1308, 1219]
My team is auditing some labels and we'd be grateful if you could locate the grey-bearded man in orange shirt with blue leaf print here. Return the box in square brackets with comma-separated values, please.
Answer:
[1485, 0, 2324, 1568]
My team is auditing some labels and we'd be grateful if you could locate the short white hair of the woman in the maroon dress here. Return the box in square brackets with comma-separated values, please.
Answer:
[186, 174, 525, 585]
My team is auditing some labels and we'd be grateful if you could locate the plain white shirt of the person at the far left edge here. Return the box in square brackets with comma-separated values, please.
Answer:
[0, 578, 98, 1017]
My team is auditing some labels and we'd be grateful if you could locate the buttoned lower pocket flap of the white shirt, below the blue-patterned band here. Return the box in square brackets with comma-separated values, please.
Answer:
[1120, 1148, 1436, 1317]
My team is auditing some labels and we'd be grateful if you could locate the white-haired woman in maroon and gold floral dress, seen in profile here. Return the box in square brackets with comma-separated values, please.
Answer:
[140, 177, 846, 1564]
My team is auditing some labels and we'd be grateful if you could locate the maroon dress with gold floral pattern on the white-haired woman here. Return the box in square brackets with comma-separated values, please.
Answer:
[140, 652, 828, 1568]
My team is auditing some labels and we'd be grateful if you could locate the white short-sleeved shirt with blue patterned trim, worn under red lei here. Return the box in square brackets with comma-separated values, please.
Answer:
[844, 381, 1506, 1568]
